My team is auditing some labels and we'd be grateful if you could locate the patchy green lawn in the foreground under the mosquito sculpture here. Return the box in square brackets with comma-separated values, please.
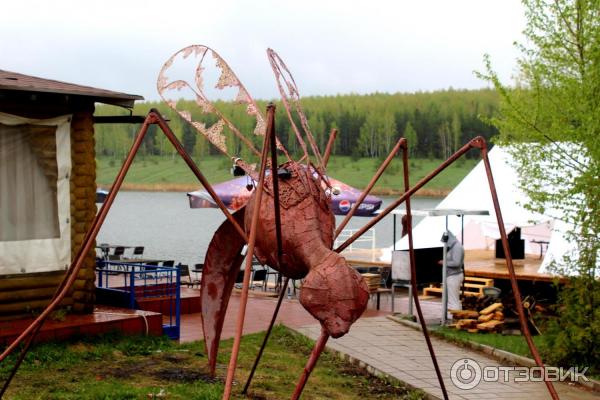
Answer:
[0, 326, 424, 400]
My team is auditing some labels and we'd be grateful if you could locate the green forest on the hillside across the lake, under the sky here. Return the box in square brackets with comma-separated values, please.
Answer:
[96, 89, 498, 159]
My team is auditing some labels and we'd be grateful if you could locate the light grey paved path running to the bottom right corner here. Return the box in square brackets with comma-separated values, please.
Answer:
[297, 316, 600, 400]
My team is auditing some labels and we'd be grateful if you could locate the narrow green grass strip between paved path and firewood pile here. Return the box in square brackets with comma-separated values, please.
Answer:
[434, 327, 549, 358]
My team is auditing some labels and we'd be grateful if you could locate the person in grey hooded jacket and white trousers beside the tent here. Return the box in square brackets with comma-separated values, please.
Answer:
[440, 231, 465, 316]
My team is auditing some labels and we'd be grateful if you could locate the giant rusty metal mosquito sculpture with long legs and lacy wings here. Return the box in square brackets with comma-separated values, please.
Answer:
[0, 45, 558, 399]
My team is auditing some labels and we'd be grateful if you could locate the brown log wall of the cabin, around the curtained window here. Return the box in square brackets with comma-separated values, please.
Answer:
[0, 102, 96, 320]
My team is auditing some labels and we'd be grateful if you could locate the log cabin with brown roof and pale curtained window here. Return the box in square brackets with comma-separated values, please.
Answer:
[0, 70, 143, 320]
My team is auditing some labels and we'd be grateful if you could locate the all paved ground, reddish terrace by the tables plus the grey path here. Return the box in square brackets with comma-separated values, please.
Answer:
[172, 293, 600, 400]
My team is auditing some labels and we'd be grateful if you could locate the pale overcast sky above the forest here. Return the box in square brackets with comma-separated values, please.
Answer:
[0, 0, 525, 100]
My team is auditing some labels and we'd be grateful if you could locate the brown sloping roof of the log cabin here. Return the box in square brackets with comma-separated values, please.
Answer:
[0, 70, 144, 108]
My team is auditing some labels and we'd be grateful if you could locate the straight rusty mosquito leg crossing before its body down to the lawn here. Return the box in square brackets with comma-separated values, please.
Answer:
[223, 104, 275, 399]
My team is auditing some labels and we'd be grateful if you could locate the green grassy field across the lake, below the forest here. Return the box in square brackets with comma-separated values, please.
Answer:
[96, 156, 476, 193]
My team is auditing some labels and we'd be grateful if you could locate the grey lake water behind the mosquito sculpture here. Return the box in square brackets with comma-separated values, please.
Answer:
[96, 192, 441, 265]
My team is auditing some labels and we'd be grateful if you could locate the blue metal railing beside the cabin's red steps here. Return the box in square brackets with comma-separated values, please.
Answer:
[96, 260, 181, 339]
